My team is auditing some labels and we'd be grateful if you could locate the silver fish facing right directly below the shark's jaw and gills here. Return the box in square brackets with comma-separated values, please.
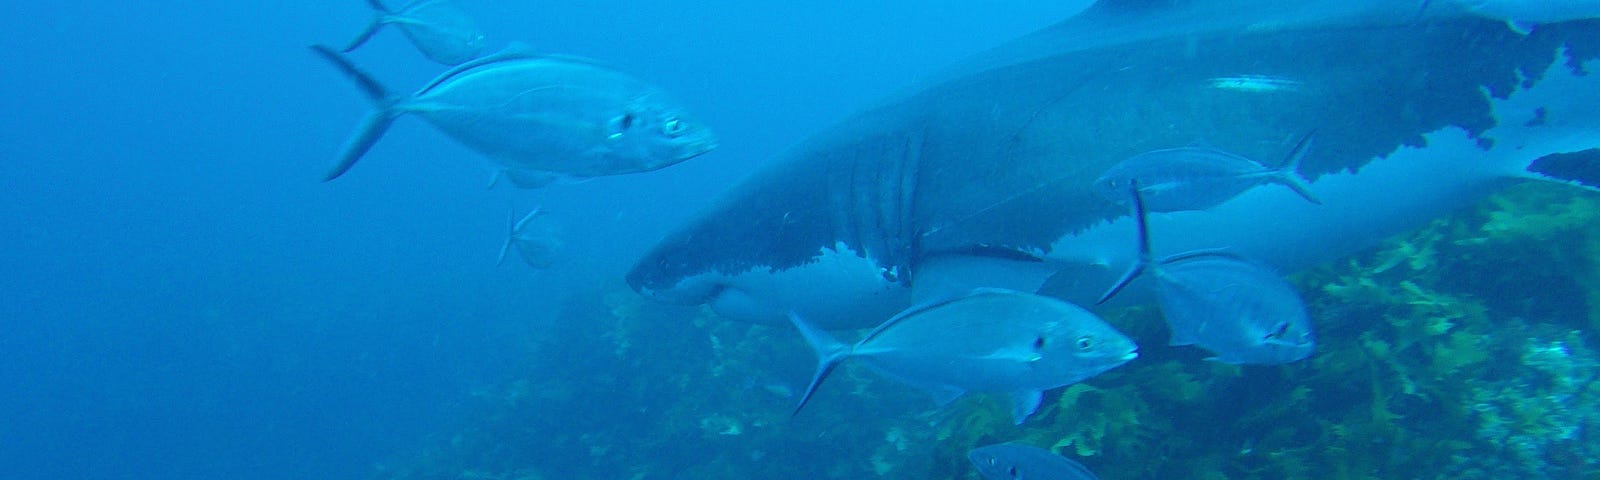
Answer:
[789, 288, 1138, 424]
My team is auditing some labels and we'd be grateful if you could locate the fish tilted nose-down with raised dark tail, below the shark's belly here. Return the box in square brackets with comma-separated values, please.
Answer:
[1098, 182, 1315, 365]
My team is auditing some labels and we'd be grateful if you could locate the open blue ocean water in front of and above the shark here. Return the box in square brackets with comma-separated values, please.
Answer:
[0, 0, 1078, 478]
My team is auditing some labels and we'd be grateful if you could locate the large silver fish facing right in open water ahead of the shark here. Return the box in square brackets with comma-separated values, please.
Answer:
[312, 45, 717, 181]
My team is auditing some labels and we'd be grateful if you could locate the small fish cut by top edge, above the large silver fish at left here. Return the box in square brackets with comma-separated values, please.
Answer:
[344, 0, 486, 66]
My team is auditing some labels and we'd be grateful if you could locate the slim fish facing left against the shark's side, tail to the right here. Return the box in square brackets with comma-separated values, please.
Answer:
[1094, 131, 1322, 211]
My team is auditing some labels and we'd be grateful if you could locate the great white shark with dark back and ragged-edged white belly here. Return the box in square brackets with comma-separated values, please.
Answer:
[627, 0, 1600, 328]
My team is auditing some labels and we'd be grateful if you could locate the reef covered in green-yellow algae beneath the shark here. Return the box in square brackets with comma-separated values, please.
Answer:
[376, 186, 1600, 480]
